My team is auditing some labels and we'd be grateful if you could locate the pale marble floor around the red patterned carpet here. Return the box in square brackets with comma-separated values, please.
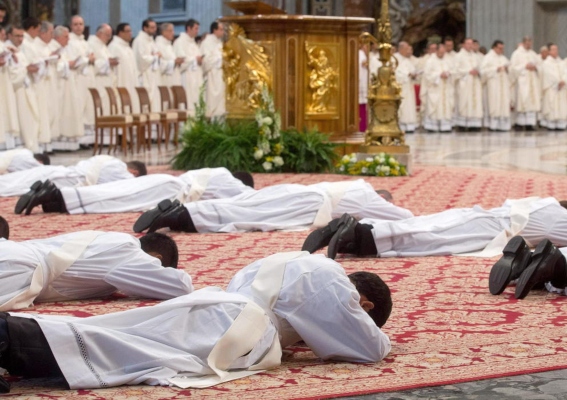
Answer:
[47, 131, 567, 400]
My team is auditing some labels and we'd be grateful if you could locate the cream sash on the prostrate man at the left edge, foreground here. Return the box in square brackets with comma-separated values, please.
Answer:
[0, 231, 103, 311]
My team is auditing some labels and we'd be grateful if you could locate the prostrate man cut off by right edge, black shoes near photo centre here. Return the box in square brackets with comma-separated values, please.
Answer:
[303, 197, 567, 258]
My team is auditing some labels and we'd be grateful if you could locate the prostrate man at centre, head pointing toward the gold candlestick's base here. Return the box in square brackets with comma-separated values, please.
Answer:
[130, 179, 413, 233]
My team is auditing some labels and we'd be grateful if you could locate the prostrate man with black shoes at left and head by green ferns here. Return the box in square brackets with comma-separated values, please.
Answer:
[15, 168, 254, 215]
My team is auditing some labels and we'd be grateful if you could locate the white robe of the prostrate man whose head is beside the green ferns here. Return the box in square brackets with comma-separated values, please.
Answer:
[61, 168, 254, 214]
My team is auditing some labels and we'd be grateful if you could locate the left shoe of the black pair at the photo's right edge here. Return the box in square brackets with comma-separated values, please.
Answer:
[488, 236, 532, 295]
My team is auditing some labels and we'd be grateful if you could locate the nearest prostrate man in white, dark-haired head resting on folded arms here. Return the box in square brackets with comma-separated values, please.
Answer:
[0, 252, 392, 391]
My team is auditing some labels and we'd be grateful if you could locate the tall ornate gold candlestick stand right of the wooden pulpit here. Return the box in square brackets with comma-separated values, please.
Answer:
[359, 0, 409, 154]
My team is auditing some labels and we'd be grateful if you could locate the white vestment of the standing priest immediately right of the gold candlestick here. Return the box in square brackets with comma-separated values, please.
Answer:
[394, 53, 418, 132]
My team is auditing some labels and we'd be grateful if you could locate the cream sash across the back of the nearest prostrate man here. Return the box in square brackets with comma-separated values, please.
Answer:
[169, 251, 309, 389]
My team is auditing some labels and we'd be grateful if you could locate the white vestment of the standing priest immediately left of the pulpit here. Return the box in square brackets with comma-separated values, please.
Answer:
[201, 34, 226, 117]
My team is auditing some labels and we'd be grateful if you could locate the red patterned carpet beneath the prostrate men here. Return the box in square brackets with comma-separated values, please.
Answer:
[0, 167, 567, 399]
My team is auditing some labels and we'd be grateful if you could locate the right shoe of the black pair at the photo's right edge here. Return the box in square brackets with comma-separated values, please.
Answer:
[515, 239, 563, 299]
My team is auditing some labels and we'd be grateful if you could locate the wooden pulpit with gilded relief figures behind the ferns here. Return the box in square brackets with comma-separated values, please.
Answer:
[221, 15, 374, 143]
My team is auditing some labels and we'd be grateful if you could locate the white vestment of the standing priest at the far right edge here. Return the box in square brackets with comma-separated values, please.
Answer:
[540, 56, 567, 130]
